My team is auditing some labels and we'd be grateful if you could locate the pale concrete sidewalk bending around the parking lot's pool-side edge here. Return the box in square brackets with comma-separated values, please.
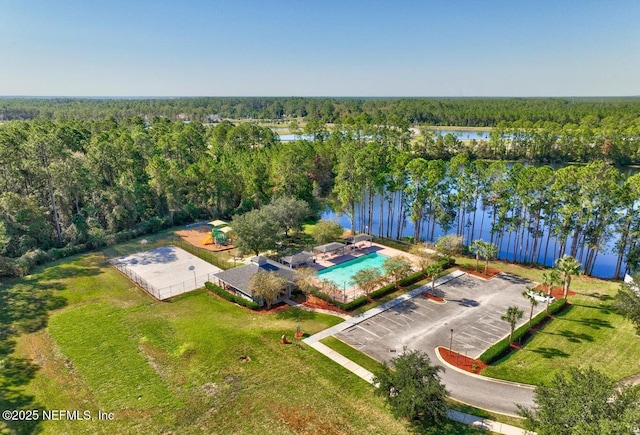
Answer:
[302, 271, 531, 435]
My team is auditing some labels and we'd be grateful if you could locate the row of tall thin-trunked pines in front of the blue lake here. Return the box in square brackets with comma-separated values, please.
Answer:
[334, 142, 640, 277]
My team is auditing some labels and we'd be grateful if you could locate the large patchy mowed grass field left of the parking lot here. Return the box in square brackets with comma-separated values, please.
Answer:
[0, 254, 484, 434]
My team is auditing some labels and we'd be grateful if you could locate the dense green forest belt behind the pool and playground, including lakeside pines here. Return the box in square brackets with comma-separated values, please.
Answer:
[0, 110, 640, 276]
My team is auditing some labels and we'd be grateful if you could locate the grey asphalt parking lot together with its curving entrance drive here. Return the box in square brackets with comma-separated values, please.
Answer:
[336, 275, 544, 415]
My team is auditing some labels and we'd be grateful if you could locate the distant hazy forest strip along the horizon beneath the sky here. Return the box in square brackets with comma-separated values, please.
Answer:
[0, 97, 640, 127]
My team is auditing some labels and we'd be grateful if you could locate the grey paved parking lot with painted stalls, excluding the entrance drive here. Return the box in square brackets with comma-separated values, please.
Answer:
[336, 274, 546, 361]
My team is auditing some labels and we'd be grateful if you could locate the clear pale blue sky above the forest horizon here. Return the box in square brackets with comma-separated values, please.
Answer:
[0, 0, 640, 97]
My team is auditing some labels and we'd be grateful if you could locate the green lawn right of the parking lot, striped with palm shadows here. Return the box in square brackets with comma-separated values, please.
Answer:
[470, 260, 640, 385]
